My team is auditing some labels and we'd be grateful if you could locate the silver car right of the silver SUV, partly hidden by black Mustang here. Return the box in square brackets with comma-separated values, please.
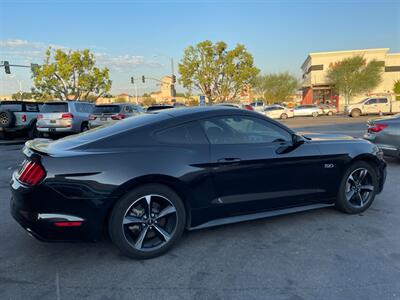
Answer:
[89, 103, 145, 128]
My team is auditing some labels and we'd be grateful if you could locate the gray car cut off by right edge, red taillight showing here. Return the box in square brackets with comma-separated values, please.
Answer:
[364, 114, 400, 158]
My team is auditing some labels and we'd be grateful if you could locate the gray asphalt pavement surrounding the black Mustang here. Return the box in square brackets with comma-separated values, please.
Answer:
[0, 117, 400, 300]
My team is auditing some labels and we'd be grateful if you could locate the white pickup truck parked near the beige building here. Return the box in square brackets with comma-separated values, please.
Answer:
[344, 97, 400, 118]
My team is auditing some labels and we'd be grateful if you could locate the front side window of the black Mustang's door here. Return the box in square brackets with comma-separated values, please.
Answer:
[200, 116, 292, 144]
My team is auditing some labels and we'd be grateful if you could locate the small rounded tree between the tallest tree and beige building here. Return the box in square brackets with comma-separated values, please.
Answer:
[255, 72, 299, 103]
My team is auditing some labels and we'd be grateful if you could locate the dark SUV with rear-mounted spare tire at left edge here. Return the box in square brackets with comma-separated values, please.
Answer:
[0, 101, 43, 139]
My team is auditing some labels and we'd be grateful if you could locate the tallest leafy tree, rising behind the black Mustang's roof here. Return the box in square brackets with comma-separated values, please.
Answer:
[178, 41, 259, 103]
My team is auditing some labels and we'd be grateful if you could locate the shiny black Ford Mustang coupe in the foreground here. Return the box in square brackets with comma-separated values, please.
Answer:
[11, 106, 386, 258]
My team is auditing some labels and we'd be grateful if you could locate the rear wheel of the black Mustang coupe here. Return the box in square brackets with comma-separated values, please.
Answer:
[108, 184, 186, 259]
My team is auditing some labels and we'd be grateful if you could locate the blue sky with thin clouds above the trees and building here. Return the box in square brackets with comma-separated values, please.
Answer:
[0, 0, 400, 95]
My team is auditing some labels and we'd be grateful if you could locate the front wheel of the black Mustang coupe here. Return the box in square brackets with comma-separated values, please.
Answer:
[335, 161, 379, 214]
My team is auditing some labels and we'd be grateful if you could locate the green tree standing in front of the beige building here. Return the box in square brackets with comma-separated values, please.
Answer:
[326, 55, 384, 105]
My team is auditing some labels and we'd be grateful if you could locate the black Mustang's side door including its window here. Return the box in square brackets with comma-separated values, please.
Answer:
[200, 115, 322, 215]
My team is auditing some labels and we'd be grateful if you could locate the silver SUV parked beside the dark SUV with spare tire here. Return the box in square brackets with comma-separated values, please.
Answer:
[36, 101, 94, 136]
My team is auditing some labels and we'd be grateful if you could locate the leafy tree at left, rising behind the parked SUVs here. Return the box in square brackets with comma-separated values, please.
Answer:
[32, 48, 112, 100]
